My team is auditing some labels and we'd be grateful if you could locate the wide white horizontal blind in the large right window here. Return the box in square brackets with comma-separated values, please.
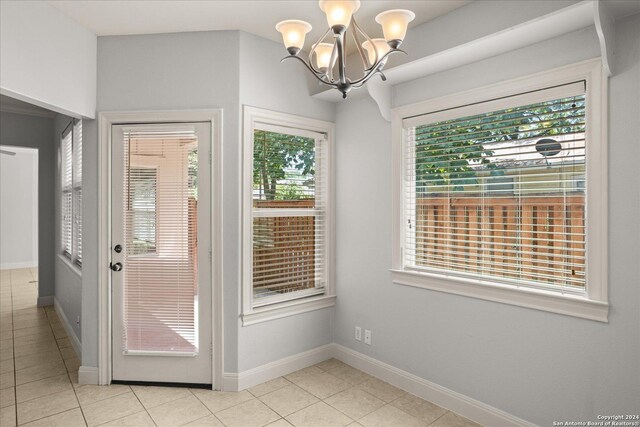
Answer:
[403, 82, 588, 294]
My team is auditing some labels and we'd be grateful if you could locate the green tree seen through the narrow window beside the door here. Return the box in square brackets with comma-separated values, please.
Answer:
[253, 130, 315, 200]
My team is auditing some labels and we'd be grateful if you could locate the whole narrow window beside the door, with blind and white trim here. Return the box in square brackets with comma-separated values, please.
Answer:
[243, 107, 333, 324]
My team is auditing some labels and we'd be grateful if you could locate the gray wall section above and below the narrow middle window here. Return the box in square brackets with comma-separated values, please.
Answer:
[235, 32, 335, 372]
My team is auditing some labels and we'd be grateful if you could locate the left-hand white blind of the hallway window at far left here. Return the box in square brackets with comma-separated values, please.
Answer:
[60, 126, 73, 259]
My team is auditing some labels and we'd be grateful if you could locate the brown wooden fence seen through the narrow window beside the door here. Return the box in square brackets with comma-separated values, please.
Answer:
[253, 199, 316, 293]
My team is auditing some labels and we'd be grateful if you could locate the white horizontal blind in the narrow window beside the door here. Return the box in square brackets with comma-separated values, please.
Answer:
[252, 125, 328, 307]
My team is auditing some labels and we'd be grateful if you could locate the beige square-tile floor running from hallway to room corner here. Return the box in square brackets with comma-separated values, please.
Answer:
[0, 269, 478, 427]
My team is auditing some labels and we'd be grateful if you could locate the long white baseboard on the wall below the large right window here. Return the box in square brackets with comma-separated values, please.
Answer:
[333, 344, 535, 427]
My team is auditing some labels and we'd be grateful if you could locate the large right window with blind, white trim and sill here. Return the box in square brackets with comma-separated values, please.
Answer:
[394, 60, 607, 320]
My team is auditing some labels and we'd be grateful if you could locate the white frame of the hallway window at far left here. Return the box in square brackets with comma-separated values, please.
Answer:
[59, 119, 82, 270]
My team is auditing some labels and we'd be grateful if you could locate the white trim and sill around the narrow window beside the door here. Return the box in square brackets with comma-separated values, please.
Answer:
[241, 105, 336, 326]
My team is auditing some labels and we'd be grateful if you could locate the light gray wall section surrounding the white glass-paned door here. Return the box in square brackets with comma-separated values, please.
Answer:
[82, 31, 239, 372]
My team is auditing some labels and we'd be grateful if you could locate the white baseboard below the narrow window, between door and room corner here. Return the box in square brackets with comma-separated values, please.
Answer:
[222, 344, 334, 391]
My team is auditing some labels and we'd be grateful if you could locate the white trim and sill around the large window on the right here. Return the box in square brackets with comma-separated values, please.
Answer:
[391, 58, 609, 322]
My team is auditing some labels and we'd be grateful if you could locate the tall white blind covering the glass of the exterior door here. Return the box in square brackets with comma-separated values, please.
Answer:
[122, 125, 198, 354]
